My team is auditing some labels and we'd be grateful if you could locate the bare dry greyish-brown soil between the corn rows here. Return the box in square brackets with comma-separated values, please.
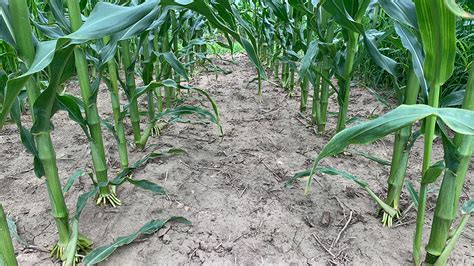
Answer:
[0, 55, 474, 265]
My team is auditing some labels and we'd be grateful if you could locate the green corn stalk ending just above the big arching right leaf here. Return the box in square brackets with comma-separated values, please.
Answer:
[336, 33, 359, 132]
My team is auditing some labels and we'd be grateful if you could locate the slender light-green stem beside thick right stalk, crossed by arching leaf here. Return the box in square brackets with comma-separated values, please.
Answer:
[413, 84, 440, 265]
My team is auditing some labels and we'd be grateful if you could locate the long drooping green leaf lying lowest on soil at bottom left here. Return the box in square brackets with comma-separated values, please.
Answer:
[83, 217, 191, 265]
